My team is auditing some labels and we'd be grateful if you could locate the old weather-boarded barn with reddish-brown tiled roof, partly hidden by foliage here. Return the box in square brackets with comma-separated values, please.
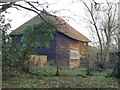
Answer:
[11, 12, 90, 68]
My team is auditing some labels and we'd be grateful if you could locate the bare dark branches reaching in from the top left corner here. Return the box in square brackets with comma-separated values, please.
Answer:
[0, 0, 58, 24]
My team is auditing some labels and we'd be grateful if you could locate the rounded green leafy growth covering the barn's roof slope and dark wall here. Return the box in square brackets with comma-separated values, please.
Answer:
[22, 18, 56, 50]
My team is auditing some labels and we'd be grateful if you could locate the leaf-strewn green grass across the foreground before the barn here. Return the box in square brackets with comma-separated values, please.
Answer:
[3, 67, 118, 88]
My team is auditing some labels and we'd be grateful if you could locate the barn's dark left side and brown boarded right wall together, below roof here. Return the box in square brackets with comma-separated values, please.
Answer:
[13, 32, 88, 67]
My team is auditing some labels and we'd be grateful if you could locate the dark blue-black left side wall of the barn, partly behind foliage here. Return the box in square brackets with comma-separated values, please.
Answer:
[12, 35, 56, 60]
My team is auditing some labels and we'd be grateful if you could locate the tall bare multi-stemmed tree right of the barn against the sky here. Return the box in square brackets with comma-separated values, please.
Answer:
[81, 0, 118, 68]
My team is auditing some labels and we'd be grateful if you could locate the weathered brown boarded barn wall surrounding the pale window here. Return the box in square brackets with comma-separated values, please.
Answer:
[56, 33, 88, 67]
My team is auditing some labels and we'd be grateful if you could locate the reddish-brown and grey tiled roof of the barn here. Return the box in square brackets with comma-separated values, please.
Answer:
[11, 11, 90, 42]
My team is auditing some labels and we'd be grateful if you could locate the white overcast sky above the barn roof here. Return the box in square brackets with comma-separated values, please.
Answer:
[3, 0, 117, 43]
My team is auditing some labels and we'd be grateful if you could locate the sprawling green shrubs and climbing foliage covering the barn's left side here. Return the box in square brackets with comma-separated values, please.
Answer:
[1, 18, 56, 75]
